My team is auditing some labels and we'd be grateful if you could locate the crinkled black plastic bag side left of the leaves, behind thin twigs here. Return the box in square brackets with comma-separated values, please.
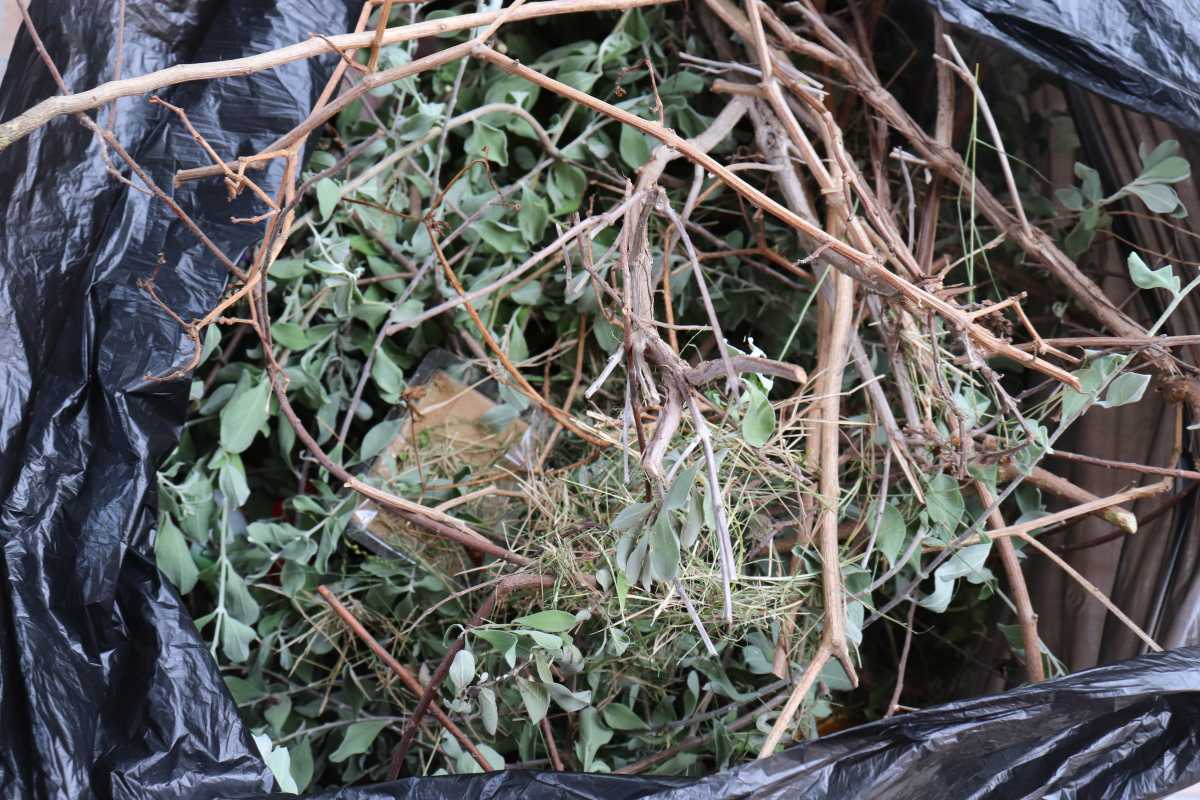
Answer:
[0, 0, 359, 799]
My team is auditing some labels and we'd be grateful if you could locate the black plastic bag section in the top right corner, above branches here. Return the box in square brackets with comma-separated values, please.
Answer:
[929, 0, 1200, 131]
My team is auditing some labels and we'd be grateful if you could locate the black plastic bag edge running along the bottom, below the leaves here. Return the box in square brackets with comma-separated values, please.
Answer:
[255, 648, 1200, 800]
